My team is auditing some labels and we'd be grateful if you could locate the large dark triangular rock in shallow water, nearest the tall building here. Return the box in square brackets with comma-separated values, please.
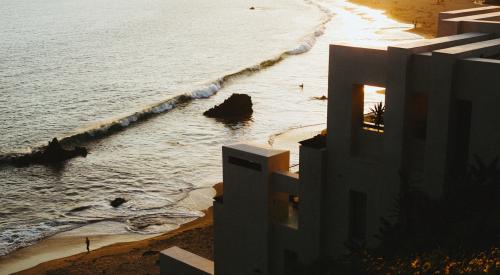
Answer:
[203, 94, 253, 119]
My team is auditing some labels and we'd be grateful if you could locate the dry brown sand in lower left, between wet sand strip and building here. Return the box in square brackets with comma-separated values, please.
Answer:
[6, 183, 222, 274]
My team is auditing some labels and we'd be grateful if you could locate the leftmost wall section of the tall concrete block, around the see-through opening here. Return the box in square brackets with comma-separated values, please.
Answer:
[323, 45, 391, 257]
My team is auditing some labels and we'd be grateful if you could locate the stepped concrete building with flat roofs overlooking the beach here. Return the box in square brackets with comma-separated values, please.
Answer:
[161, 6, 500, 275]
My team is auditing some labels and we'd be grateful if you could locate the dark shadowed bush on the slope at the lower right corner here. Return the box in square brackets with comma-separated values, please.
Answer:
[337, 156, 500, 274]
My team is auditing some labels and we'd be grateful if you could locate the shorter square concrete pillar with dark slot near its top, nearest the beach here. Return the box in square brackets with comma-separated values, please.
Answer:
[214, 144, 290, 275]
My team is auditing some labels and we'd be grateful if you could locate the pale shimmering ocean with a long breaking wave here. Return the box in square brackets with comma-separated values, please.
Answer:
[0, 0, 421, 256]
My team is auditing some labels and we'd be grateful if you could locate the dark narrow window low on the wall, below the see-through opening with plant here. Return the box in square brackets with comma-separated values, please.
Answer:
[349, 190, 367, 241]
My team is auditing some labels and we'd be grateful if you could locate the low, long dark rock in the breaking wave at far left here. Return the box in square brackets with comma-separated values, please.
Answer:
[11, 138, 88, 166]
